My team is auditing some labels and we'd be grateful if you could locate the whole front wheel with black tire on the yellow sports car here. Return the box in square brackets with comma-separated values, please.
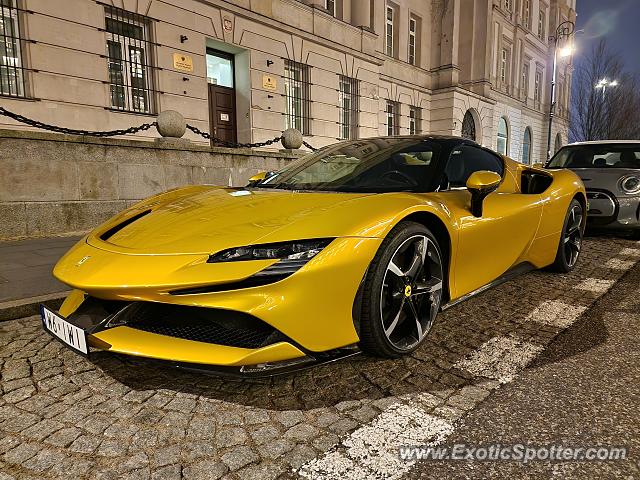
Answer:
[360, 222, 445, 358]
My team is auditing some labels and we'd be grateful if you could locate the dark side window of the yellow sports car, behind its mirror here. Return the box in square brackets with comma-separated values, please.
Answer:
[440, 145, 504, 190]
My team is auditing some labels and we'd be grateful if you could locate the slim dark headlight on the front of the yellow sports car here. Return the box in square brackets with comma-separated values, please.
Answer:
[207, 238, 333, 263]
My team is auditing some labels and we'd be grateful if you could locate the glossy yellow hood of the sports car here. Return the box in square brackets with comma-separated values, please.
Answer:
[87, 187, 376, 255]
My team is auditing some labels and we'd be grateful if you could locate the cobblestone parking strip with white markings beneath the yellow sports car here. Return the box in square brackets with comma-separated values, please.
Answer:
[0, 237, 640, 479]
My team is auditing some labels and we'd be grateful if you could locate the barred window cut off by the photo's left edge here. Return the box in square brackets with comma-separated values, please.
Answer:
[0, 0, 26, 97]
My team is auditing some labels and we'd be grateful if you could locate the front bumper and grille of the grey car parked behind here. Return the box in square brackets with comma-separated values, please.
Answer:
[587, 189, 640, 230]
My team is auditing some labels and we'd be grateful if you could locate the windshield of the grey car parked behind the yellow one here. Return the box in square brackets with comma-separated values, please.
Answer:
[547, 143, 640, 168]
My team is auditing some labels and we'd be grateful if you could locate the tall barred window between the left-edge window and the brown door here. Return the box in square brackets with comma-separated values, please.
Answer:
[105, 7, 155, 114]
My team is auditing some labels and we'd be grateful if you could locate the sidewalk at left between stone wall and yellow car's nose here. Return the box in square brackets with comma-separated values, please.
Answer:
[0, 237, 78, 321]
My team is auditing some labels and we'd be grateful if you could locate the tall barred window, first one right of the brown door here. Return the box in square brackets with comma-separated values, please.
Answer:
[284, 60, 311, 135]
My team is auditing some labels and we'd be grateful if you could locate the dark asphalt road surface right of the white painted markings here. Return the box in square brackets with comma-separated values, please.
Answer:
[409, 253, 640, 480]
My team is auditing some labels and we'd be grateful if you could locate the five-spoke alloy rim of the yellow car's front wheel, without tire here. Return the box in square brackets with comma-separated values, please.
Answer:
[380, 235, 443, 351]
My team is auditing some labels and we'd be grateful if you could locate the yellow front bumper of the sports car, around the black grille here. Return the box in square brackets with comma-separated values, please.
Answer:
[54, 238, 381, 366]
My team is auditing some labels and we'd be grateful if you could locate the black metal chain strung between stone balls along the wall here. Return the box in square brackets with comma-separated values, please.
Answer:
[0, 107, 317, 152]
